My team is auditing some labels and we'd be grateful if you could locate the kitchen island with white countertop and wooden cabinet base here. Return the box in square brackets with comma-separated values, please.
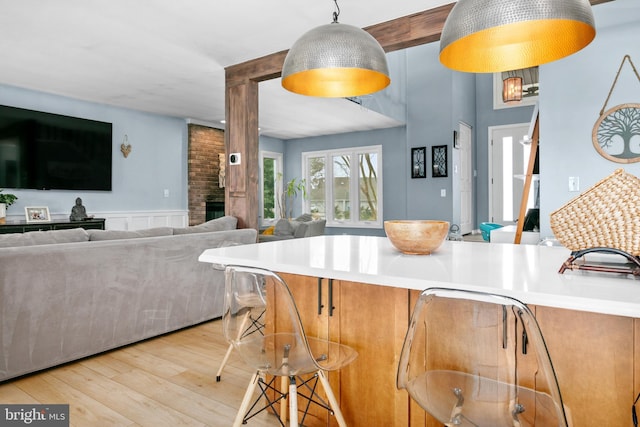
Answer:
[200, 235, 640, 426]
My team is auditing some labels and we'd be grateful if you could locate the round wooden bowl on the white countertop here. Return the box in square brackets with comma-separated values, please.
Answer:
[384, 220, 449, 255]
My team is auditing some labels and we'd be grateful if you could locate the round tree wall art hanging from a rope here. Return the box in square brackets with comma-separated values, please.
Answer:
[591, 55, 640, 163]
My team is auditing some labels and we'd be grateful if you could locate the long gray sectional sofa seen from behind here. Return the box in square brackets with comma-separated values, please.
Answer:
[0, 217, 257, 382]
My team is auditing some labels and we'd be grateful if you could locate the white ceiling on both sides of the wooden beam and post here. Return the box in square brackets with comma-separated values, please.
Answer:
[0, 0, 452, 139]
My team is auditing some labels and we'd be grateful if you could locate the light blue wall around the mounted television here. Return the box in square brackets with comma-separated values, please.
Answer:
[0, 85, 188, 216]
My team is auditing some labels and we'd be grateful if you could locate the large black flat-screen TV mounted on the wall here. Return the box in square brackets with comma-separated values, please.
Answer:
[0, 106, 112, 191]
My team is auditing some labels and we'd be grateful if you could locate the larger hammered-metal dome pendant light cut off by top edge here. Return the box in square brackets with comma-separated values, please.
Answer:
[440, 0, 596, 73]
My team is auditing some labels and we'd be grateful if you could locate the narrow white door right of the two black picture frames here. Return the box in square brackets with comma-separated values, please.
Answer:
[458, 122, 473, 234]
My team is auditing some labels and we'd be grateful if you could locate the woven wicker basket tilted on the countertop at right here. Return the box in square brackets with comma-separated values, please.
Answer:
[550, 169, 640, 256]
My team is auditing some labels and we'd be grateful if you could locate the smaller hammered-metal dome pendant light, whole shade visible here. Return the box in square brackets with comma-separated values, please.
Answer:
[282, 0, 391, 98]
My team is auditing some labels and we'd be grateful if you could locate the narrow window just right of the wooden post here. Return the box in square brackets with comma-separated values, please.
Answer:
[260, 151, 282, 226]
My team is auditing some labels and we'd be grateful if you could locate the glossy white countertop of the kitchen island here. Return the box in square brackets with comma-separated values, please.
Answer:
[199, 235, 640, 318]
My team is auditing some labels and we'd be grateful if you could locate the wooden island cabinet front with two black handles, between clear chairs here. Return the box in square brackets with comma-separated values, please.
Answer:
[280, 273, 409, 427]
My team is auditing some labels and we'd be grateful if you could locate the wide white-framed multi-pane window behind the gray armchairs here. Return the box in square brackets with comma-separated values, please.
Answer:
[302, 145, 382, 228]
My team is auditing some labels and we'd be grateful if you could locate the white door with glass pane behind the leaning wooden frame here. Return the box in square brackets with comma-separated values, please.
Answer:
[489, 123, 535, 225]
